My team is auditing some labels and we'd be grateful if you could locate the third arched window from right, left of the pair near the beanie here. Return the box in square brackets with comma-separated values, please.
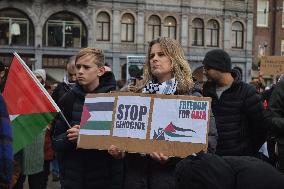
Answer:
[192, 18, 204, 46]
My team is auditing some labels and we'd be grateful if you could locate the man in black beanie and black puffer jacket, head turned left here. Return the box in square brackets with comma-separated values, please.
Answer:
[203, 49, 269, 156]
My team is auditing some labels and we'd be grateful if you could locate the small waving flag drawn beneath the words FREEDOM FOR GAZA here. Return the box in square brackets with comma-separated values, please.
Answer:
[164, 122, 195, 137]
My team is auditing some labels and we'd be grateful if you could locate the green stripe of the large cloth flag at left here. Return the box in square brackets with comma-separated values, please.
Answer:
[12, 112, 58, 154]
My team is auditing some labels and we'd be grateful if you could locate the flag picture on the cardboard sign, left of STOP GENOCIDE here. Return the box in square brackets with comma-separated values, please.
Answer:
[80, 97, 115, 135]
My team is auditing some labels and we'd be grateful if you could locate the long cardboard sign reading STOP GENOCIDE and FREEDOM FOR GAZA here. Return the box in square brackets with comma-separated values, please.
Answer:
[77, 93, 211, 157]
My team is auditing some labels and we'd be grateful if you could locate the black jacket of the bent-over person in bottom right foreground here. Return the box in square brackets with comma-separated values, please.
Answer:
[175, 153, 284, 189]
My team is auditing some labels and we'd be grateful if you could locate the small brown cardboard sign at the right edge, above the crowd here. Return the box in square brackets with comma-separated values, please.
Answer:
[260, 56, 284, 75]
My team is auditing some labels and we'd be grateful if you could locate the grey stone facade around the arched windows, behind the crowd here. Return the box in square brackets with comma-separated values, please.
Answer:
[0, 0, 255, 81]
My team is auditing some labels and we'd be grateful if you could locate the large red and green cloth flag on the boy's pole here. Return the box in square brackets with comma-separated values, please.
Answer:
[3, 53, 60, 153]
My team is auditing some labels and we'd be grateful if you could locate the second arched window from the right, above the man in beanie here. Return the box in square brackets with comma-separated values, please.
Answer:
[206, 20, 219, 47]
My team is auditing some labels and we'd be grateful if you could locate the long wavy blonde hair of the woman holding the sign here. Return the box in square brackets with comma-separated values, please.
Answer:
[139, 37, 194, 94]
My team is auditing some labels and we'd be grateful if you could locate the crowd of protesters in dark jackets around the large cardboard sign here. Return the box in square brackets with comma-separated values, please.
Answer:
[0, 37, 284, 189]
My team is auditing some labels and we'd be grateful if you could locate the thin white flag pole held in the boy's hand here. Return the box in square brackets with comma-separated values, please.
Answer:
[13, 52, 72, 128]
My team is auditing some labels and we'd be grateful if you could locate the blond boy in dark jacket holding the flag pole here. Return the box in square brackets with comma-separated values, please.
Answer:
[54, 48, 123, 189]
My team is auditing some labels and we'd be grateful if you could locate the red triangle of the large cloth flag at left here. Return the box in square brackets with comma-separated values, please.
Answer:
[3, 56, 57, 115]
